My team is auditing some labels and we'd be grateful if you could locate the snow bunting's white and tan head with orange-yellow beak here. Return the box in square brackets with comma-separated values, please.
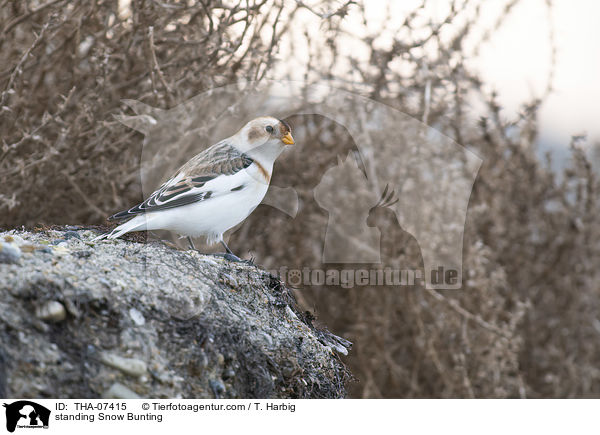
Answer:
[235, 116, 294, 151]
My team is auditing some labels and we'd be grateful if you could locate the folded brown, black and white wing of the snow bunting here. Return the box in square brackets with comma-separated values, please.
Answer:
[109, 141, 254, 220]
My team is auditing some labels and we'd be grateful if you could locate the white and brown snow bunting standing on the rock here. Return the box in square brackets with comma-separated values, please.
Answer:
[94, 116, 294, 258]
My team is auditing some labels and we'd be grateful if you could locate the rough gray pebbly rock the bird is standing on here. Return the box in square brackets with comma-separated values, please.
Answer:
[0, 227, 350, 398]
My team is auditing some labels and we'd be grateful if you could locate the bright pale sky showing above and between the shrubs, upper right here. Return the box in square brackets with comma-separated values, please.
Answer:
[348, 0, 600, 167]
